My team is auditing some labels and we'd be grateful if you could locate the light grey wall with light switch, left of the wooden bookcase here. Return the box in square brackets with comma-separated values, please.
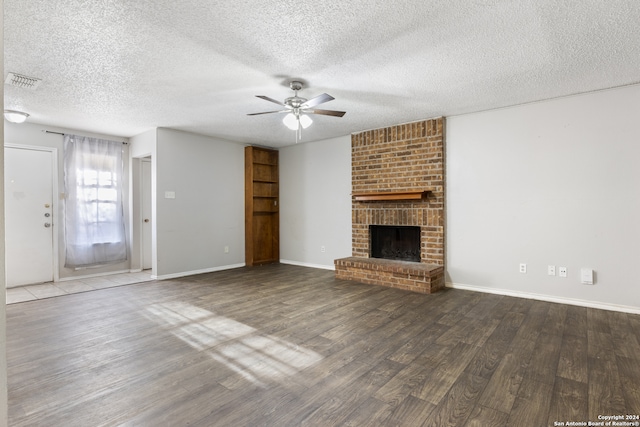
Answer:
[152, 128, 244, 278]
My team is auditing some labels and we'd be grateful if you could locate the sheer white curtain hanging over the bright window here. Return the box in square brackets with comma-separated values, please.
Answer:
[64, 135, 127, 268]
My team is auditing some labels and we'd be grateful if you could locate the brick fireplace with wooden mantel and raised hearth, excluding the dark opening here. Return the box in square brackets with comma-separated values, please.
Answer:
[335, 117, 445, 293]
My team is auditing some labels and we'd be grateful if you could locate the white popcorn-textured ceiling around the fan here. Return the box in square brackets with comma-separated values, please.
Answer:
[4, 0, 640, 147]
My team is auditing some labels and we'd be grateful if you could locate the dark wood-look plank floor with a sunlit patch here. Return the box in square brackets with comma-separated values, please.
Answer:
[7, 265, 640, 427]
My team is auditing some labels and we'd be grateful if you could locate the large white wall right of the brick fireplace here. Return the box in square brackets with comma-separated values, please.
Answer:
[446, 86, 640, 311]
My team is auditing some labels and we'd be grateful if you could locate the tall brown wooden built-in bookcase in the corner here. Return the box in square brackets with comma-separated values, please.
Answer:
[245, 147, 280, 266]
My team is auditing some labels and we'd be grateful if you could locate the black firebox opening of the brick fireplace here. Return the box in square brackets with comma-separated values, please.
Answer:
[369, 225, 420, 262]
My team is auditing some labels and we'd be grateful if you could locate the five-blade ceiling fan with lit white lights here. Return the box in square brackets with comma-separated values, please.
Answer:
[247, 80, 345, 142]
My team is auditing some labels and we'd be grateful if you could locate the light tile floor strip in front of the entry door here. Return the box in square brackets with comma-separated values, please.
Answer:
[7, 271, 153, 304]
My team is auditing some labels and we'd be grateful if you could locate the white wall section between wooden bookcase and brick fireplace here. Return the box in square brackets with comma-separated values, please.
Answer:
[280, 135, 351, 269]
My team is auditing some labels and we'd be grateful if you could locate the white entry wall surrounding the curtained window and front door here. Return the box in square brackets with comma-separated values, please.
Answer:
[4, 120, 129, 280]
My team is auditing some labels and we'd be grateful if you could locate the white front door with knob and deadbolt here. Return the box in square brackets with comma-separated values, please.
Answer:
[4, 147, 57, 287]
